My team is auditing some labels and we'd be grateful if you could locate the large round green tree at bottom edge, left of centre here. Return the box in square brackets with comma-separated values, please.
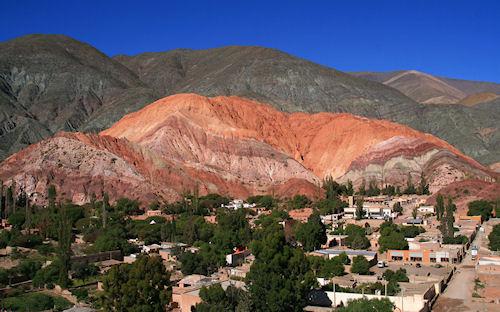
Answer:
[101, 255, 171, 312]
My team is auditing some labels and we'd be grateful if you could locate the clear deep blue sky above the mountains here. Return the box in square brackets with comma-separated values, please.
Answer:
[0, 0, 500, 82]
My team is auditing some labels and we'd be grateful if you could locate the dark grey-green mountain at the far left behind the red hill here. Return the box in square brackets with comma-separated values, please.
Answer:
[0, 35, 154, 159]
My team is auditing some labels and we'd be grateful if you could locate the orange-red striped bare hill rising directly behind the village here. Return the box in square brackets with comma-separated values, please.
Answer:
[0, 94, 494, 202]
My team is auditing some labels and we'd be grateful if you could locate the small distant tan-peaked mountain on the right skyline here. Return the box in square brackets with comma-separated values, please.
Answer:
[351, 70, 500, 105]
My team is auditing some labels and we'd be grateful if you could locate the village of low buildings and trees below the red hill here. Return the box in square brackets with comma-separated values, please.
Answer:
[0, 182, 500, 312]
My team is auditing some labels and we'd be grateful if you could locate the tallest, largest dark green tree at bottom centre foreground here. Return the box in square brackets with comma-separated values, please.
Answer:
[246, 231, 316, 311]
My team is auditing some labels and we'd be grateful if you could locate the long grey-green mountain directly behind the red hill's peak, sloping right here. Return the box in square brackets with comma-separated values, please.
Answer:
[115, 47, 500, 163]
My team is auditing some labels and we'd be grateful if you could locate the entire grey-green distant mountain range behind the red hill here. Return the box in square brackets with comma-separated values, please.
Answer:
[0, 35, 500, 164]
